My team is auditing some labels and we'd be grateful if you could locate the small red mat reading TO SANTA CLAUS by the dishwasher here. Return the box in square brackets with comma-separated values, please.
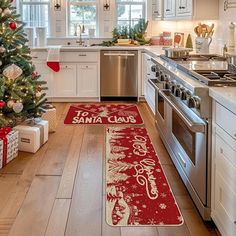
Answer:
[64, 104, 143, 124]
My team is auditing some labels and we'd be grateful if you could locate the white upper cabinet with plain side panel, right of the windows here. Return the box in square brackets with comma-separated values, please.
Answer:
[152, 0, 219, 20]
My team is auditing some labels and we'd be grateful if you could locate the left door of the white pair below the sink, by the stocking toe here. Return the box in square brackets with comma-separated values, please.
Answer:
[53, 63, 77, 97]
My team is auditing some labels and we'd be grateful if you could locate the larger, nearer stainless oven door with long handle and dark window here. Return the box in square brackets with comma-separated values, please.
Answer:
[159, 90, 207, 205]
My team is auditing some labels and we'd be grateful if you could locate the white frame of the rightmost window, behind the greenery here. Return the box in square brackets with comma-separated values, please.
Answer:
[115, 0, 147, 27]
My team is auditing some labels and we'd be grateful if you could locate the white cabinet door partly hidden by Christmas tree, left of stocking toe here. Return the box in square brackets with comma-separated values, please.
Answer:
[33, 61, 53, 98]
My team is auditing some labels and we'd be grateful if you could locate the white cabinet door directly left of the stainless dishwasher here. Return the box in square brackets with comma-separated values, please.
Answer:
[77, 63, 99, 98]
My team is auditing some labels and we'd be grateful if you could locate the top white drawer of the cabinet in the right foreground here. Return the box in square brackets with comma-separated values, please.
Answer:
[215, 103, 236, 140]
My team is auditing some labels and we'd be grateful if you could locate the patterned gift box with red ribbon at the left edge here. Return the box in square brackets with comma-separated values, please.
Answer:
[0, 128, 19, 169]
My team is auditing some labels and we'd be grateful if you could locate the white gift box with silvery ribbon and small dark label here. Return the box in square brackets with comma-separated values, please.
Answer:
[14, 120, 48, 153]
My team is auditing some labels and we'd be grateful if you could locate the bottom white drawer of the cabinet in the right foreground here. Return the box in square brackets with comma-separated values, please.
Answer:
[213, 171, 236, 236]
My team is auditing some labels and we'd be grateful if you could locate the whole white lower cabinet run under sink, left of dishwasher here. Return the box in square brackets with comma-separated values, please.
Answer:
[31, 51, 100, 101]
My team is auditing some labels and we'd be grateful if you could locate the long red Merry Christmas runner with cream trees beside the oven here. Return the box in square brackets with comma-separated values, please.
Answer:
[106, 127, 183, 226]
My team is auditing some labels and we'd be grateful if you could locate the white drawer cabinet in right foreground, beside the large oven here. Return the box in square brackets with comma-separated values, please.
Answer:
[211, 101, 236, 236]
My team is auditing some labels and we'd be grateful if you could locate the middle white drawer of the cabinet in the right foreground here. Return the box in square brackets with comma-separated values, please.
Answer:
[215, 128, 236, 193]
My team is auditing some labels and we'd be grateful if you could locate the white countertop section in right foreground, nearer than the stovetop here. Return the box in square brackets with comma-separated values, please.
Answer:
[210, 87, 236, 114]
